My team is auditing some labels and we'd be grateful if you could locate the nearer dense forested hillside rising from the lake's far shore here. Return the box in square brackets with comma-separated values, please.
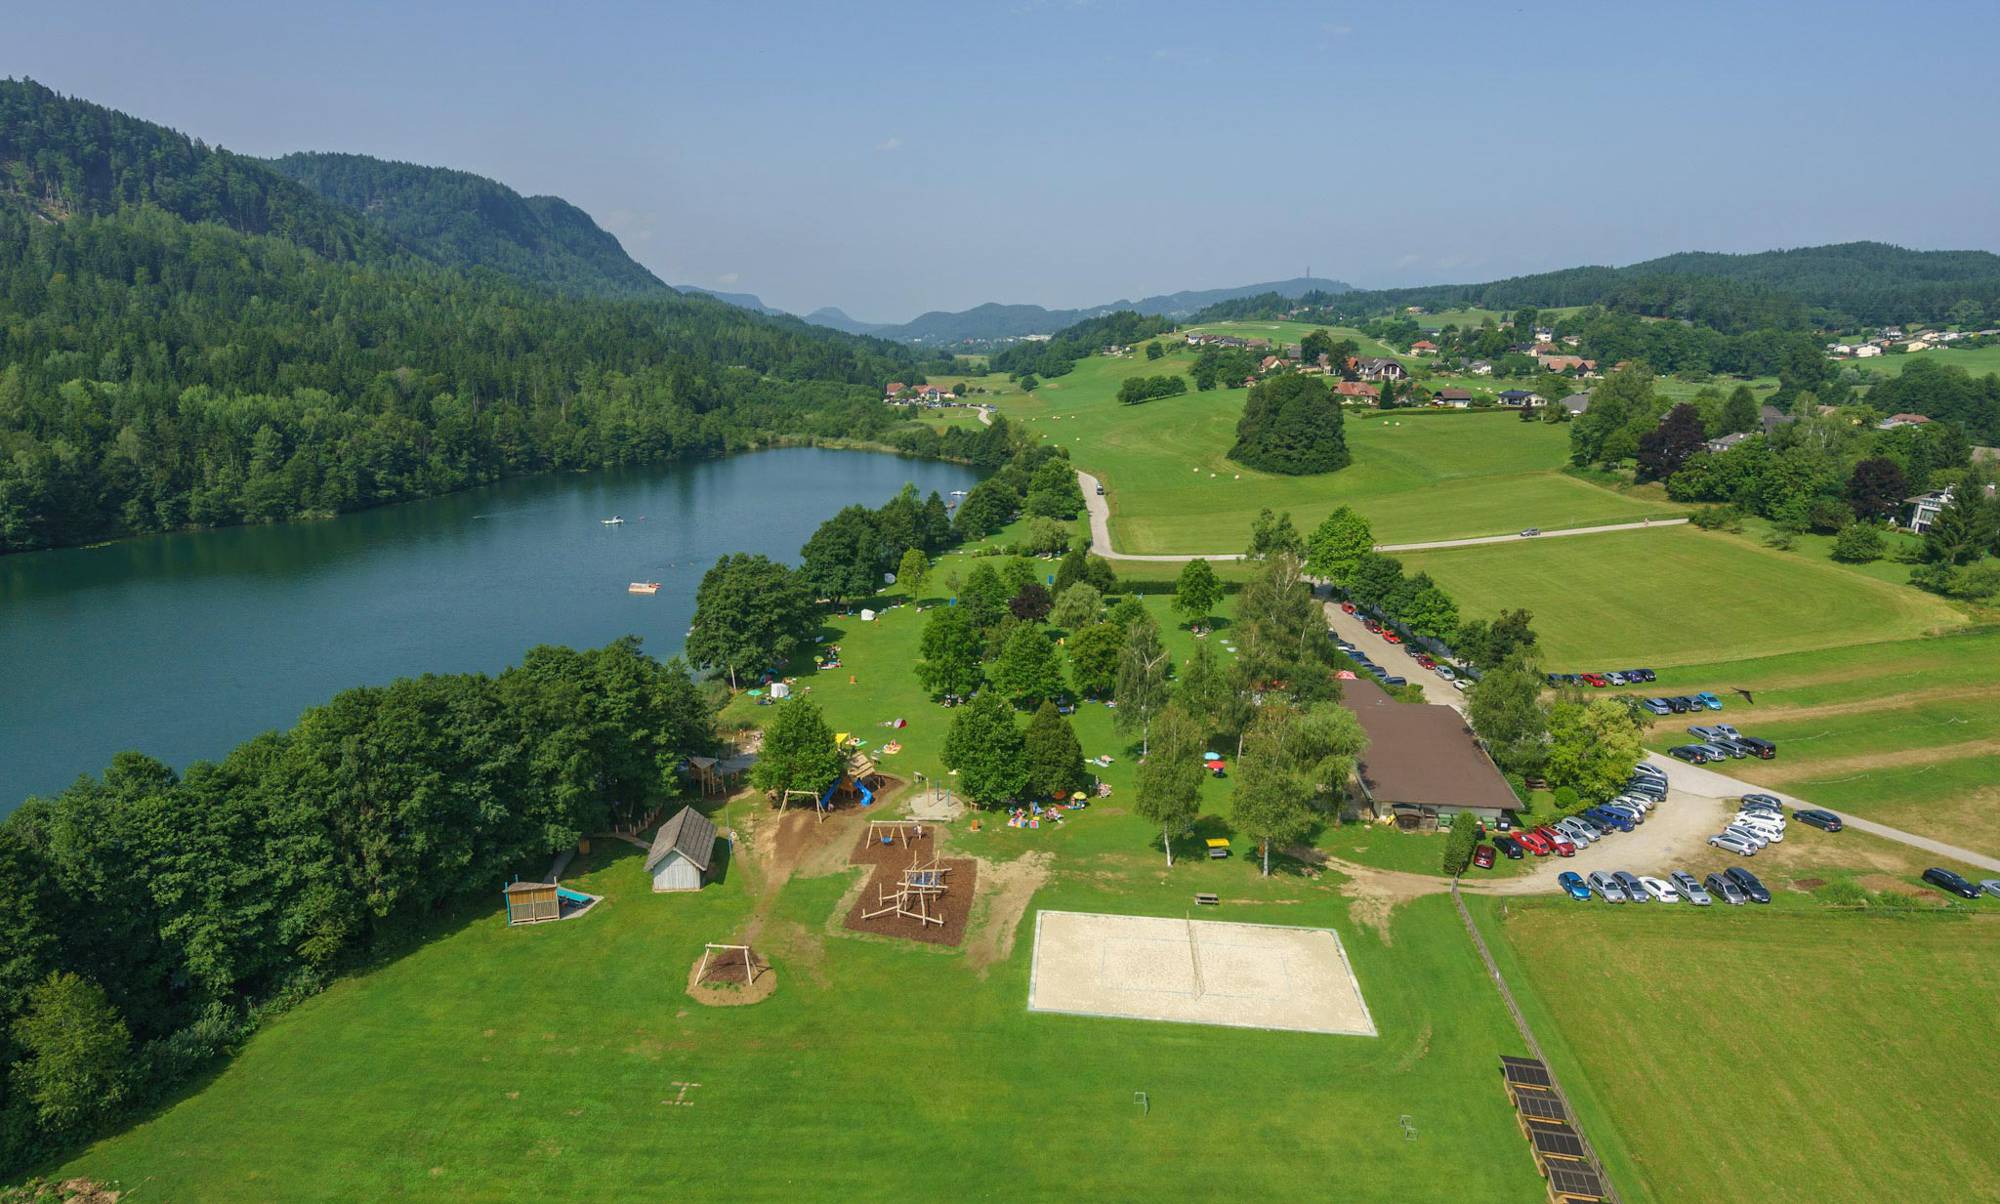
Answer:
[0, 82, 920, 552]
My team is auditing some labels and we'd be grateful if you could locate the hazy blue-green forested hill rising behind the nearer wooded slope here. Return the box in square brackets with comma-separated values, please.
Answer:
[270, 152, 666, 296]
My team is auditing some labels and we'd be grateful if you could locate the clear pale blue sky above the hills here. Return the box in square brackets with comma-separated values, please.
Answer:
[11, 0, 2000, 320]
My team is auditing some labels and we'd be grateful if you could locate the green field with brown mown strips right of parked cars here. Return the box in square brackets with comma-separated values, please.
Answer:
[1624, 628, 2000, 856]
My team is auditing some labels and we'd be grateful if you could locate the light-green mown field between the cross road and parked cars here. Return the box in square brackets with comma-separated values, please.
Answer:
[1402, 526, 1964, 672]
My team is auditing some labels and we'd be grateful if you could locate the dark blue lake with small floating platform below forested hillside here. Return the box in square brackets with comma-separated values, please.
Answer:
[0, 448, 978, 814]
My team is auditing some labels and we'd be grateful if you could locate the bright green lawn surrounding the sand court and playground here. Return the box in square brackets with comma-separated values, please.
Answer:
[52, 558, 1542, 1204]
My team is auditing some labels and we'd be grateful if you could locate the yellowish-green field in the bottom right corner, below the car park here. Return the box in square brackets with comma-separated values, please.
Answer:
[1474, 900, 2000, 1202]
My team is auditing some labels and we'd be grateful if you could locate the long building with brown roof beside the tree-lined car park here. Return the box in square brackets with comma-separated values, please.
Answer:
[1340, 680, 1520, 828]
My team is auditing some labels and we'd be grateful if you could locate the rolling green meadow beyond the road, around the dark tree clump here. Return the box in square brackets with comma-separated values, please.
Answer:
[1000, 352, 1682, 554]
